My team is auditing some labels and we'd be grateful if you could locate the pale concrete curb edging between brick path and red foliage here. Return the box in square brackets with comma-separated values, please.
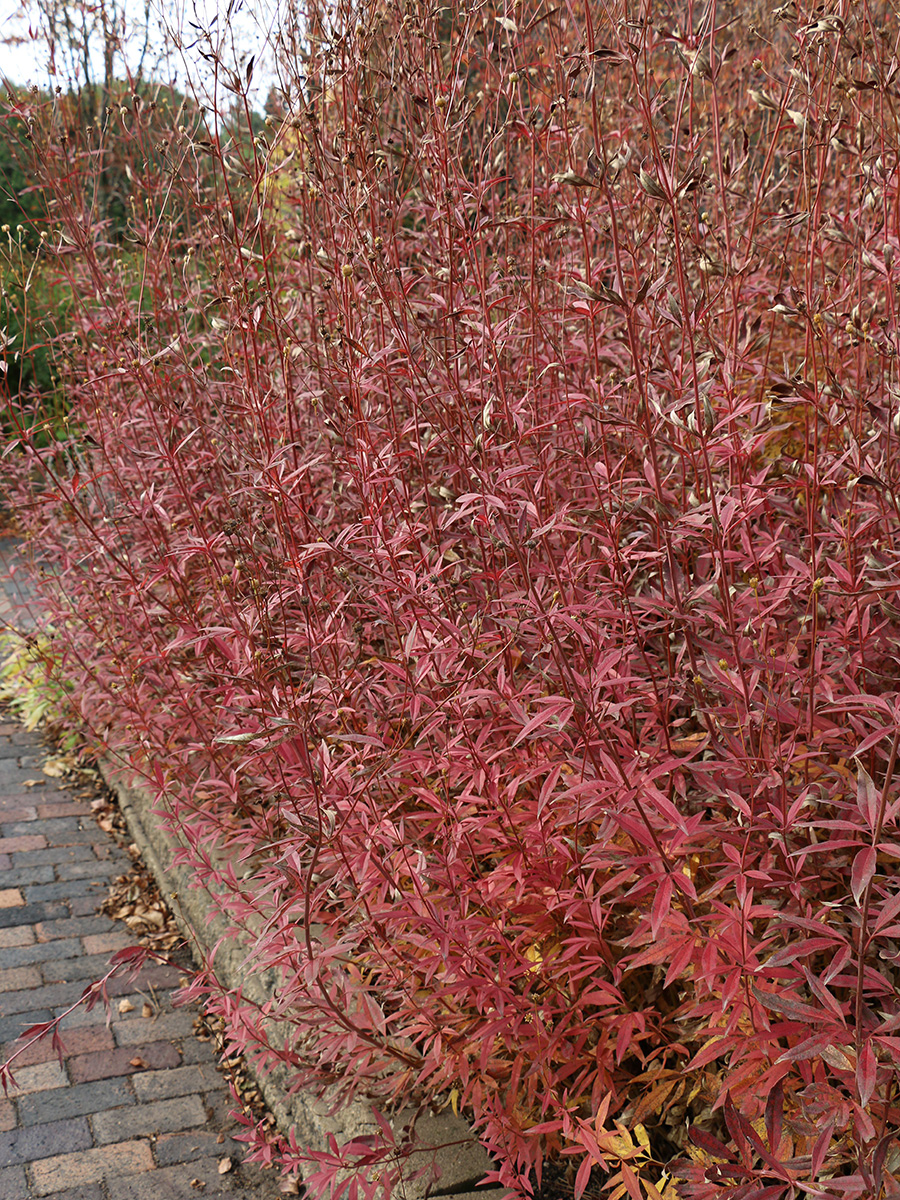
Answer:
[101, 762, 506, 1200]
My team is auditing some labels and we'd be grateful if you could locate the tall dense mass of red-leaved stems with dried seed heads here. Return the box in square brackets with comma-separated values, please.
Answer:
[6, 0, 900, 1200]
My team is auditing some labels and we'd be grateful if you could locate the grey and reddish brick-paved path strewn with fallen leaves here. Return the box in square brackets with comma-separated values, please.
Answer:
[0, 696, 281, 1200]
